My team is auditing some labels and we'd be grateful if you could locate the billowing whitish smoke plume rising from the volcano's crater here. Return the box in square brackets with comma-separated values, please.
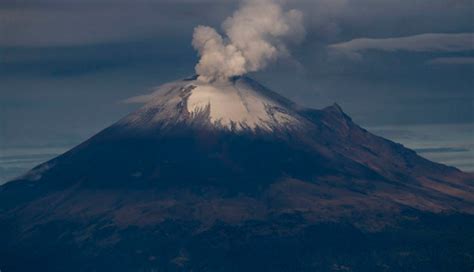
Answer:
[192, 0, 305, 82]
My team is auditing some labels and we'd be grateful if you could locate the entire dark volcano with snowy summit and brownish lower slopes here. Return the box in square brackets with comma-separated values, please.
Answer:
[0, 76, 474, 271]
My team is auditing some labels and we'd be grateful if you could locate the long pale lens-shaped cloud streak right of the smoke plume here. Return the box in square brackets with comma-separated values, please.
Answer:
[328, 33, 474, 58]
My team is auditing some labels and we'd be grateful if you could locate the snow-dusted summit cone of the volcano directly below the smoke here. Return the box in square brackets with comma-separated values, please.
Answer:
[122, 77, 300, 131]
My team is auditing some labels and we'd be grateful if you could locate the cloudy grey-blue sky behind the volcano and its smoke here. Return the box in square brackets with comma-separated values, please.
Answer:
[0, 0, 474, 183]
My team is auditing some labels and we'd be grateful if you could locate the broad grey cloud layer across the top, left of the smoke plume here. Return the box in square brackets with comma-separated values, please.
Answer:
[0, 0, 233, 47]
